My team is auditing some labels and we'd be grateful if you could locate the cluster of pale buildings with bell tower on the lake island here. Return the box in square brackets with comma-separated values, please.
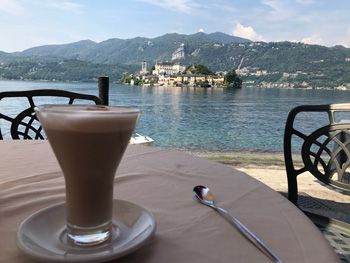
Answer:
[134, 61, 225, 86]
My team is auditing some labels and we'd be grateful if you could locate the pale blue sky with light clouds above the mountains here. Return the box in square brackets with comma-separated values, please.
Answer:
[0, 0, 350, 52]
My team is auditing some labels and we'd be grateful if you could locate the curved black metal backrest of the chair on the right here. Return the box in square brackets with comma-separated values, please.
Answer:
[284, 103, 350, 205]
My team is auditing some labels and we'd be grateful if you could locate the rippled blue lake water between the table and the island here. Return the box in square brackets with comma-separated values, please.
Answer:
[0, 81, 350, 152]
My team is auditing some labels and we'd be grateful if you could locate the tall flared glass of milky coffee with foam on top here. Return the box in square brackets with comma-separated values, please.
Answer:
[35, 105, 141, 246]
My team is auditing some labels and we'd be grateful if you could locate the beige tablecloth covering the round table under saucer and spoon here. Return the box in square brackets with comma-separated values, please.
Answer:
[0, 141, 339, 263]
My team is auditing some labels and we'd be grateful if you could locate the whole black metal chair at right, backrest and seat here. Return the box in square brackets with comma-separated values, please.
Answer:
[284, 103, 350, 262]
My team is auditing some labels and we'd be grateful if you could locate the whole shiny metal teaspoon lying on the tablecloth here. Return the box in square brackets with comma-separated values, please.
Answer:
[193, 185, 283, 263]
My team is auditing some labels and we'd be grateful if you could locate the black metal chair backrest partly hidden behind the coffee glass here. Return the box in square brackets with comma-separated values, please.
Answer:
[0, 89, 102, 140]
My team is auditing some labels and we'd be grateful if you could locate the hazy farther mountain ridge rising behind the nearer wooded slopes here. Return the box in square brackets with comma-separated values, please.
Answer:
[17, 32, 251, 64]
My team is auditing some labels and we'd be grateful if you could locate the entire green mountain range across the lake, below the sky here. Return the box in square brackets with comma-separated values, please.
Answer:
[0, 32, 350, 87]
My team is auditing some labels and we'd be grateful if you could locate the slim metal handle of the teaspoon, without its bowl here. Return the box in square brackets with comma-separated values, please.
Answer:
[210, 205, 283, 263]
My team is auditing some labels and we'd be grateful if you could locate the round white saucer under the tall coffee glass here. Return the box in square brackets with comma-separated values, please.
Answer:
[17, 200, 157, 263]
